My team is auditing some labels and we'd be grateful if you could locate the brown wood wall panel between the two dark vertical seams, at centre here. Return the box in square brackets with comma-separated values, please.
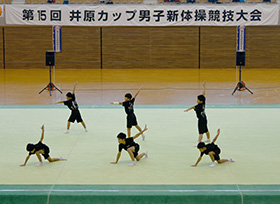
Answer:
[103, 27, 198, 68]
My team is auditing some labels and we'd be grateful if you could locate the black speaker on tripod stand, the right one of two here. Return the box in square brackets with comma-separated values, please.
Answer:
[231, 51, 253, 95]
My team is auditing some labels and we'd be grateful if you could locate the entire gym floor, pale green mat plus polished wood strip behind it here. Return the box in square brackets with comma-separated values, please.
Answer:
[0, 69, 280, 204]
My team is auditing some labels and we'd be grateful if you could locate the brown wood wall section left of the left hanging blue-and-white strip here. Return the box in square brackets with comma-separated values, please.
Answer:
[5, 26, 52, 69]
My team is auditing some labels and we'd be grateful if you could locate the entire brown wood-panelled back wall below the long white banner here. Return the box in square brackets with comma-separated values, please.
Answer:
[0, 26, 280, 69]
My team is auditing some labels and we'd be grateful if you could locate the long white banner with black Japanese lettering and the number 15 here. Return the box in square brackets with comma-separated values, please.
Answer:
[5, 4, 279, 26]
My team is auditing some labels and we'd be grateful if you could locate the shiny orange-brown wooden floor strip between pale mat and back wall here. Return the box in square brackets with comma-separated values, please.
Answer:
[0, 69, 280, 105]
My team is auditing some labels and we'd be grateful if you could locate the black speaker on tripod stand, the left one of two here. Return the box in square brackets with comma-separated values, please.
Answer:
[39, 51, 62, 96]
